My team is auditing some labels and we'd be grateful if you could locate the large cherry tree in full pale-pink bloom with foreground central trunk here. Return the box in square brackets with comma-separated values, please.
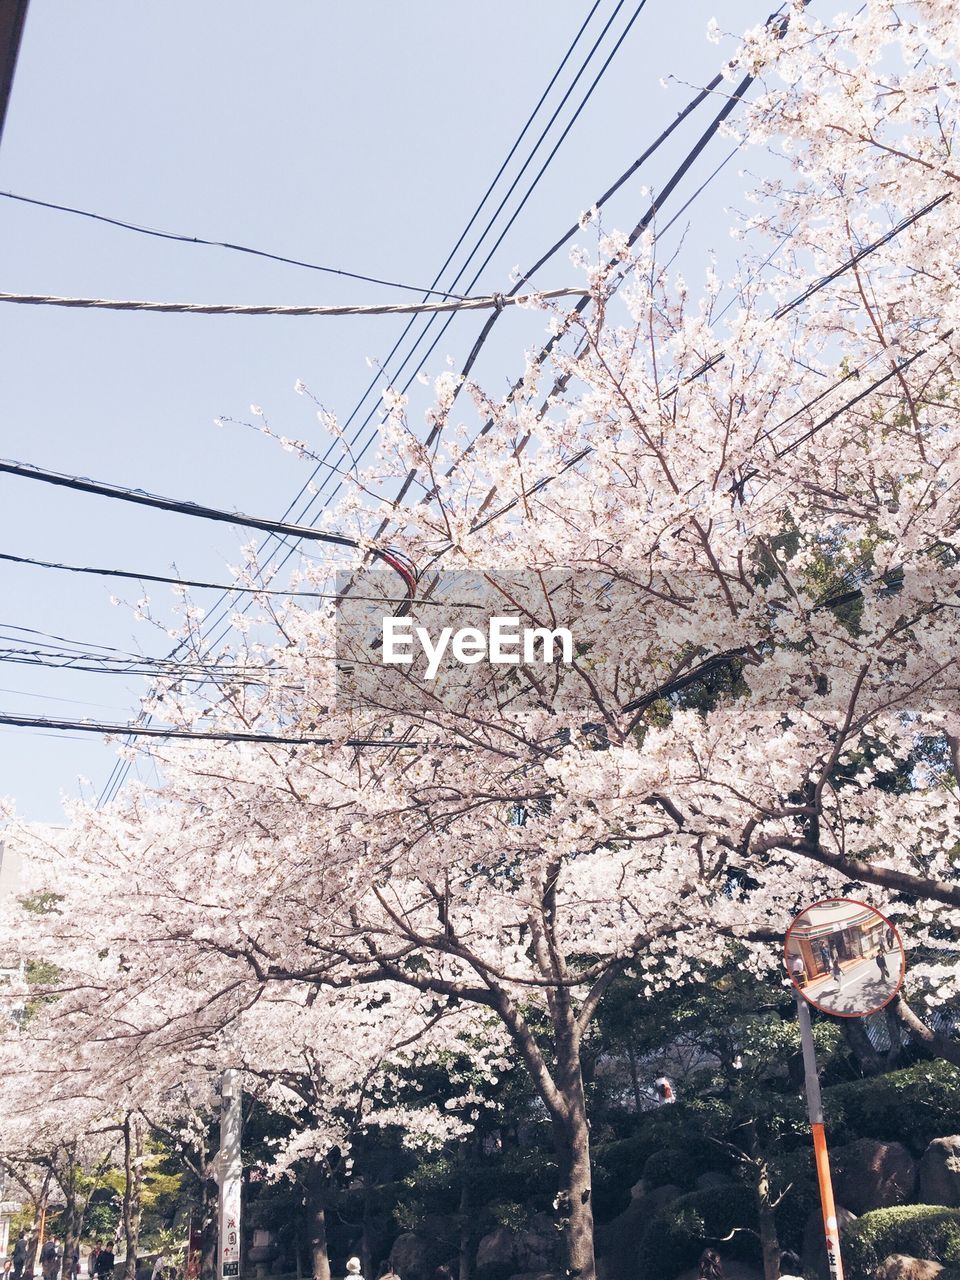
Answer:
[5, 0, 960, 1280]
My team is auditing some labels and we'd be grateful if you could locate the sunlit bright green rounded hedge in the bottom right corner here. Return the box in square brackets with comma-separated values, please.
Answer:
[844, 1204, 960, 1280]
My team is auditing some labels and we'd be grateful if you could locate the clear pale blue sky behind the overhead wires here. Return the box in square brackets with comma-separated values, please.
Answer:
[0, 0, 769, 820]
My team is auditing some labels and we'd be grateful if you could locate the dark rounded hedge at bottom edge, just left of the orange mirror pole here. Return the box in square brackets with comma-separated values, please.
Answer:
[636, 1184, 760, 1280]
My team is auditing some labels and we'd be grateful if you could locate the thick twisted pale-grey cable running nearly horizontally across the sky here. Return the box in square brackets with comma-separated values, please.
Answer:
[0, 285, 584, 316]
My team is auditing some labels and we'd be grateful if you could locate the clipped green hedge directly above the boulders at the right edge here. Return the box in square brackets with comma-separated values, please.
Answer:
[823, 1061, 960, 1156]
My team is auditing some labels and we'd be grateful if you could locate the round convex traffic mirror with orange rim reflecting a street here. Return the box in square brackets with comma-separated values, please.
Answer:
[785, 897, 906, 1018]
